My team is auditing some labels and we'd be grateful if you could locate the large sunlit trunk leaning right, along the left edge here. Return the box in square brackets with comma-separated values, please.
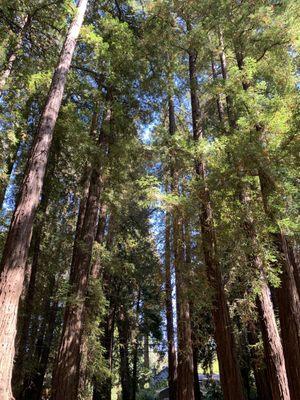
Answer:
[0, 0, 88, 400]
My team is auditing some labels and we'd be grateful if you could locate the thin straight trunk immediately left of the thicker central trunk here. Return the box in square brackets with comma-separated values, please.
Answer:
[165, 213, 177, 400]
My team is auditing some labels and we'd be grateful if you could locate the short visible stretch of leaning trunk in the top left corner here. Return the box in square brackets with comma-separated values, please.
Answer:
[0, 15, 31, 95]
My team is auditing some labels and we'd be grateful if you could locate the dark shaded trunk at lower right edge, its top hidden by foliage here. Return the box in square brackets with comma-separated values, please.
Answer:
[236, 46, 300, 400]
